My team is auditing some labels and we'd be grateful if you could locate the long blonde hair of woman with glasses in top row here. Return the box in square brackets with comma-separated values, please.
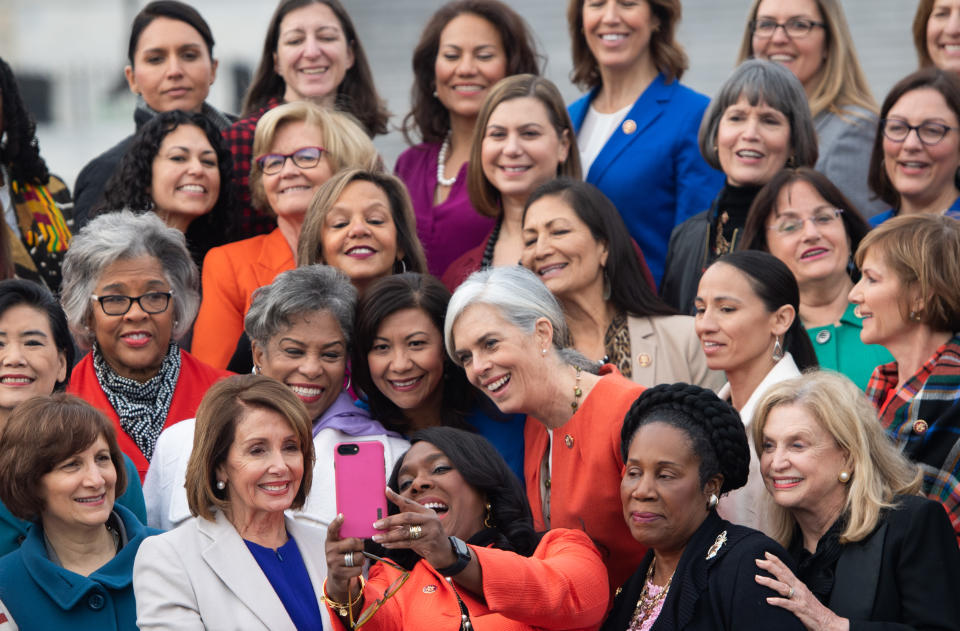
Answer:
[737, 0, 877, 118]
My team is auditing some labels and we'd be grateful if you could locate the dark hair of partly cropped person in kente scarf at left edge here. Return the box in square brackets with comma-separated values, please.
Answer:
[0, 57, 50, 186]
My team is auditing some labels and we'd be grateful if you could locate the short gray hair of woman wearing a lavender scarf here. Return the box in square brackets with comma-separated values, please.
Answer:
[243, 265, 357, 349]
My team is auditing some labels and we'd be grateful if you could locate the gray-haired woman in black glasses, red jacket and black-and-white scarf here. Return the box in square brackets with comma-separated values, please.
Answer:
[61, 211, 229, 479]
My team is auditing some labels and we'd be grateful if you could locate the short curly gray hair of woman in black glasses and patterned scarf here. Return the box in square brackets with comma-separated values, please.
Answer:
[60, 210, 200, 347]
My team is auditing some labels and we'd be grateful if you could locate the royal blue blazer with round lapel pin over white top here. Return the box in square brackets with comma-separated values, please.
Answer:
[568, 74, 725, 285]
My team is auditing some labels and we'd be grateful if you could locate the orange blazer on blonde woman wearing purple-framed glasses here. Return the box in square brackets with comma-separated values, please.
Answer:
[190, 228, 296, 369]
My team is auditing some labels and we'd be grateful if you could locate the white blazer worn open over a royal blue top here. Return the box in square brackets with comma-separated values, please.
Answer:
[133, 511, 332, 631]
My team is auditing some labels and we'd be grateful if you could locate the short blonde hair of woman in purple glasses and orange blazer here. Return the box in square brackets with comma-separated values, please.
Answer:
[250, 101, 380, 212]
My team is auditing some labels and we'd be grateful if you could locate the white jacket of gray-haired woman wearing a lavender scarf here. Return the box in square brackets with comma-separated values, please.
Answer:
[143, 419, 410, 530]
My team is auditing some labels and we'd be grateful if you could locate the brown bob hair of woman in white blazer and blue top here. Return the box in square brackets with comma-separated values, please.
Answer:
[184, 375, 314, 521]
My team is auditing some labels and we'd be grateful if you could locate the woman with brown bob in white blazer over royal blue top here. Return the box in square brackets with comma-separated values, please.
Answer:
[133, 375, 330, 631]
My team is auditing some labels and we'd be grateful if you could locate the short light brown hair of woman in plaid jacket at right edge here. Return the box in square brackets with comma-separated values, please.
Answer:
[853, 213, 960, 333]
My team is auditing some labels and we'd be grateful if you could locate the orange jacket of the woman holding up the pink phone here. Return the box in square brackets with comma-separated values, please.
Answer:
[330, 529, 610, 631]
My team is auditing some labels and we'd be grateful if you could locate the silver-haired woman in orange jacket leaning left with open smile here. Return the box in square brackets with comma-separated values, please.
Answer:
[444, 266, 646, 588]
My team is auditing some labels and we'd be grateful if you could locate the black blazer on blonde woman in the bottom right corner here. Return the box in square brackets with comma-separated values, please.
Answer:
[816, 495, 960, 631]
